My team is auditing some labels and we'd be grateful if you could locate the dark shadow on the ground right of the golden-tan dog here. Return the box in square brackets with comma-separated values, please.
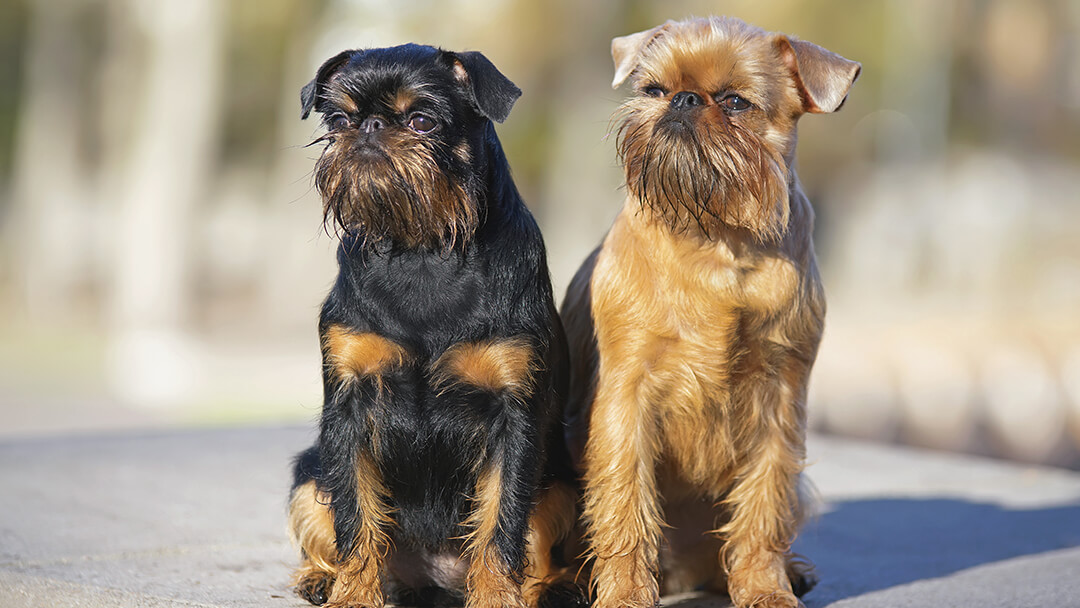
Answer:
[664, 499, 1080, 608]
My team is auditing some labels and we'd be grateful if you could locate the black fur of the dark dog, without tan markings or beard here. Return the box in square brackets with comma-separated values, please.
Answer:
[285, 44, 572, 605]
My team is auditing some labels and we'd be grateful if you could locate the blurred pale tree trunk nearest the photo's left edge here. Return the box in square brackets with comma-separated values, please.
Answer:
[5, 0, 99, 321]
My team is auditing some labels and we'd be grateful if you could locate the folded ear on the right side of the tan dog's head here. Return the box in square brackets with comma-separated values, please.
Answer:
[777, 36, 863, 113]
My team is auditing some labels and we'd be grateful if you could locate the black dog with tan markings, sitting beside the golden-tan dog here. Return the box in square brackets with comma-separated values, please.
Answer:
[288, 44, 577, 608]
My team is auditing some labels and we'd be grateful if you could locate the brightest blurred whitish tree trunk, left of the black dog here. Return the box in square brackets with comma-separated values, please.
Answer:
[109, 0, 225, 405]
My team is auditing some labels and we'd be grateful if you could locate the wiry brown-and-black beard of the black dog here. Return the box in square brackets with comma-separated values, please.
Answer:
[315, 129, 480, 249]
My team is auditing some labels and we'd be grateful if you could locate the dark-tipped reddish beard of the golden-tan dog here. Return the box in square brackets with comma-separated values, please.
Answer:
[617, 100, 788, 241]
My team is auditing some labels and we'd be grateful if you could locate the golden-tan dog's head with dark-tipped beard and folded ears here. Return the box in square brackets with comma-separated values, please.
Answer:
[611, 17, 861, 240]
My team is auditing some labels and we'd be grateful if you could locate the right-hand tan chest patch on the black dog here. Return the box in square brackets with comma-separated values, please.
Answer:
[434, 339, 537, 396]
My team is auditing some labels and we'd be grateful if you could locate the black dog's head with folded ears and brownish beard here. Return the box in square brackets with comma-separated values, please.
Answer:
[300, 44, 521, 249]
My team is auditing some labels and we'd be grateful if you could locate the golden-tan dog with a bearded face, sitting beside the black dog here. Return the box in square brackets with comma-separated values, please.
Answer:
[562, 17, 861, 608]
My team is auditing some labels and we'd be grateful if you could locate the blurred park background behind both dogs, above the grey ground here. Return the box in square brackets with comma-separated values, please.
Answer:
[0, 0, 1080, 468]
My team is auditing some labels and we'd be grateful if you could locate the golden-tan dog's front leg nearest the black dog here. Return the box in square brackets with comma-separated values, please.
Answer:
[584, 353, 662, 608]
